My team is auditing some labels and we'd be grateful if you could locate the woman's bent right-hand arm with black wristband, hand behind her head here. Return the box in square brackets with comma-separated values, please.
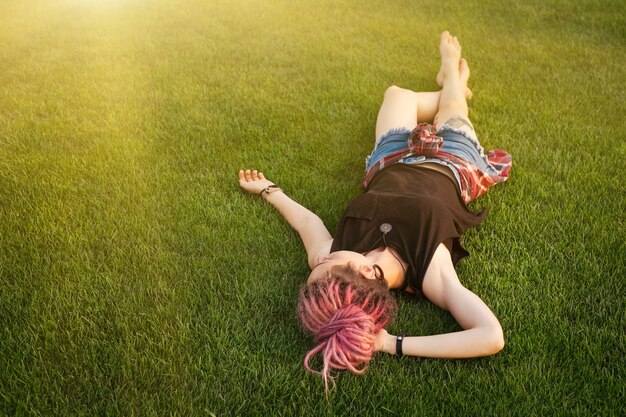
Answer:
[376, 244, 504, 359]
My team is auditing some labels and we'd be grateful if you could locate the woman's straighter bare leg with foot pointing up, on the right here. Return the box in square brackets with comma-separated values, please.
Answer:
[435, 32, 473, 132]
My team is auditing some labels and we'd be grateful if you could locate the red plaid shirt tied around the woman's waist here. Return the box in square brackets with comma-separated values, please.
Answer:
[361, 123, 512, 204]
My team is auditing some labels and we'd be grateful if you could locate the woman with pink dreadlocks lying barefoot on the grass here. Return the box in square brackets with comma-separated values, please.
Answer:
[239, 32, 511, 386]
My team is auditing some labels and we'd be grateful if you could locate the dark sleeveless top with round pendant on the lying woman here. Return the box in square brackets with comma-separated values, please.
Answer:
[330, 164, 487, 293]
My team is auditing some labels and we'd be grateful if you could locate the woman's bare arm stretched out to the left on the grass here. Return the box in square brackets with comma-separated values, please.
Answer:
[239, 169, 333, 268]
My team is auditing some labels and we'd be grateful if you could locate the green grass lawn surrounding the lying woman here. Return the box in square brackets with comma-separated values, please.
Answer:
[0, 0, 626, 416]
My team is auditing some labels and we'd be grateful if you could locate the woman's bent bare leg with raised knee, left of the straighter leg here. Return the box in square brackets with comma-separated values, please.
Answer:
[376, 86, 441, 139]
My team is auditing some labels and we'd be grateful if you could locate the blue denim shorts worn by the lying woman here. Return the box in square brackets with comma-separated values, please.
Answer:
[365, 117, 497, 188]
